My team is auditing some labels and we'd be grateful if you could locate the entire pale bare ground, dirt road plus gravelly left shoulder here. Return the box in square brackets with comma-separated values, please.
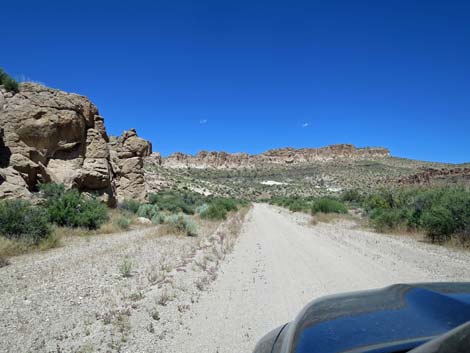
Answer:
[0, 204, 470, 353]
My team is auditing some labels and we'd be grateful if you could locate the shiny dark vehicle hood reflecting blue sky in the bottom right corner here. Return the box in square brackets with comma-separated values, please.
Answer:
[274, 283, 470, 353]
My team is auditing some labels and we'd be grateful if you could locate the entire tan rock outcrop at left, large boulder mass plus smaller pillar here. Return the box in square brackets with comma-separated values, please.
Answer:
[0, 83, 152, 205]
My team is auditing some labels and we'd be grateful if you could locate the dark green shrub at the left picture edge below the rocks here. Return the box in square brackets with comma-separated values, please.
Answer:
[0, 200, 51, 244]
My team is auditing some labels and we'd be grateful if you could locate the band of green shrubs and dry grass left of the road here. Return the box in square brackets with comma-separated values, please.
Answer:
[0, 183, 247, 266]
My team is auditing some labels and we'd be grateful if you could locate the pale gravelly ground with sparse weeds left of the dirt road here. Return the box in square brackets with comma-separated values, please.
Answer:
[0, 210, 246, 353]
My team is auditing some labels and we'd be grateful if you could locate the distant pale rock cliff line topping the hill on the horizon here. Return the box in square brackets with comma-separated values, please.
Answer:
[162, 144, 390, 169]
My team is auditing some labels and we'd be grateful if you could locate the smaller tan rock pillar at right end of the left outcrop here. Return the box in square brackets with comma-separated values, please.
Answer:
[109, 129, 152, 200]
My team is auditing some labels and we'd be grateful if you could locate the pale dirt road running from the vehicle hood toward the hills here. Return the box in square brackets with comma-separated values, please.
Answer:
[167, 205, 470, 353]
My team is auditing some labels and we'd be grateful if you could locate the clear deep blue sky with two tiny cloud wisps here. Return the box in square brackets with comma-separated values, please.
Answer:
[0, 0, 470, 162]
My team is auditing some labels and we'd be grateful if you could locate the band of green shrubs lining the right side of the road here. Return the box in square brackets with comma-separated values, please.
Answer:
[269, 186, 470, 246]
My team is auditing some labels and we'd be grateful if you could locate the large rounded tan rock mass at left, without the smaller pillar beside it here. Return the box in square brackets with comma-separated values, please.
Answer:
[0, 83, 115, 204]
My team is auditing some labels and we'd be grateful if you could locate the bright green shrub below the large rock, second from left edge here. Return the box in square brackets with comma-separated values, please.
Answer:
[40, 184, 108, 229]
